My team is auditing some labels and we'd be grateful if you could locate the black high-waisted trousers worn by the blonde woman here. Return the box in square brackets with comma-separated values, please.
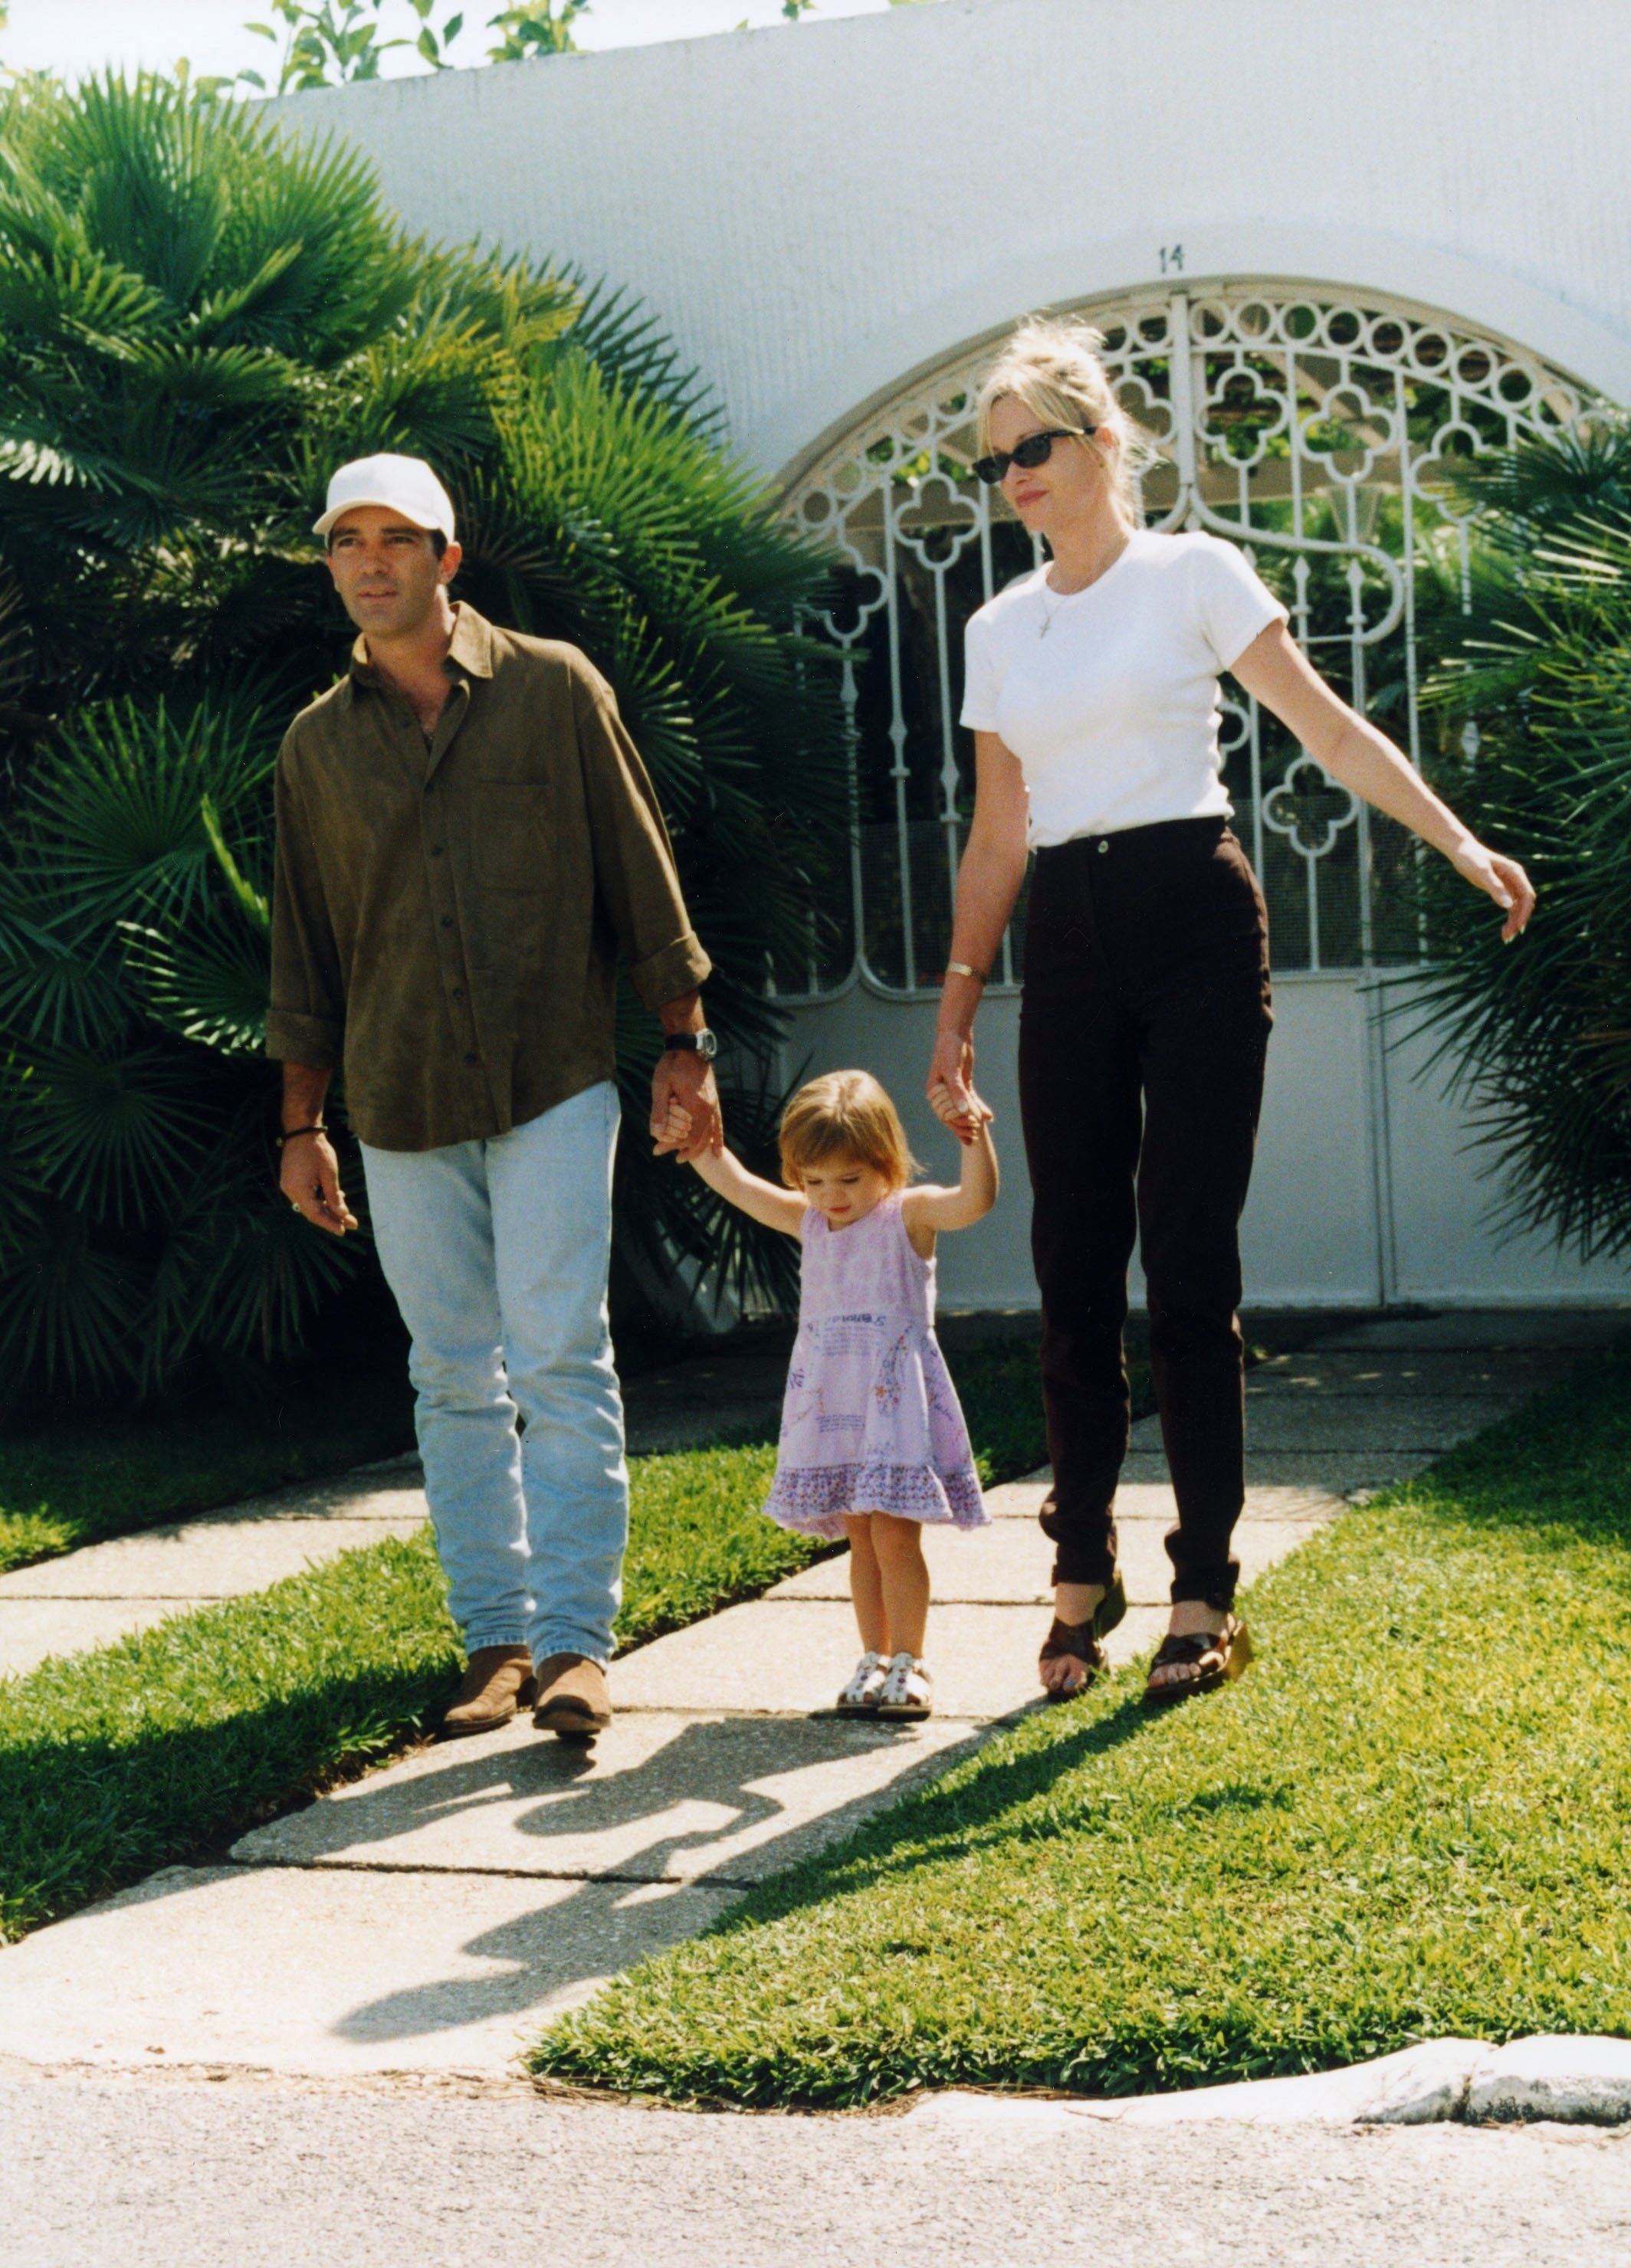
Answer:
[1019, 819, 1272, 1608]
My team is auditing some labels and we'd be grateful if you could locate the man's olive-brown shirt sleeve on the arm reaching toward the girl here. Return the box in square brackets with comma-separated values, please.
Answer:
[574, 669, 712, 1009]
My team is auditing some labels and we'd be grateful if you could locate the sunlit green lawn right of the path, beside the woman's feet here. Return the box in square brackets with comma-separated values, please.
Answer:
[533, 1352, 1631, 2107]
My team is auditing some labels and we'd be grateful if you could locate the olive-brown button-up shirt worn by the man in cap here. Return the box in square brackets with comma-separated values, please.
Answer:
[265, 605, 710, 1150]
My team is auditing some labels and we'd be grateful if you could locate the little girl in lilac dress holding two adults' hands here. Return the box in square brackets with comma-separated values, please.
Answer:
[662, 1070, 996, 1717]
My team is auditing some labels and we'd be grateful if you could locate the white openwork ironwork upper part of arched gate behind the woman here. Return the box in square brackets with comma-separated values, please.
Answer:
[778, 284, 1597, 998]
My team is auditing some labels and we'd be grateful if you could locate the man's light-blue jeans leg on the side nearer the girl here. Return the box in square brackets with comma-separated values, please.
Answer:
[485, 1082, 628, 1663]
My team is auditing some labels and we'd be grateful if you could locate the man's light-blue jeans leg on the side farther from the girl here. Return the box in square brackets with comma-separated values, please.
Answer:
[363, 1141, 533, 1653]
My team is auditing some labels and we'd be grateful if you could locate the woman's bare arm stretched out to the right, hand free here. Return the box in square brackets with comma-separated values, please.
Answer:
[1229, 621, 1536, 943]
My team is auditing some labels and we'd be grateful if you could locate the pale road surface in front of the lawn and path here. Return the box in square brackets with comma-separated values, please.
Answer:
[0, 2066, 1631, 2268]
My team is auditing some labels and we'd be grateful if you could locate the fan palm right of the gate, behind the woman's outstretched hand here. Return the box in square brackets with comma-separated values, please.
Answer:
[1418, 420, 1631, 1259]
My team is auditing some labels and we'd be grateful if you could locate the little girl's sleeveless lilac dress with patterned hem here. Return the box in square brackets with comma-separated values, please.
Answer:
[764, 1191, 989, 1538]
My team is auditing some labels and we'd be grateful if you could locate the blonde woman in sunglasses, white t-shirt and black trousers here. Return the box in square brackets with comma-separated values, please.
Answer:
[928, 322, 1534, 1703]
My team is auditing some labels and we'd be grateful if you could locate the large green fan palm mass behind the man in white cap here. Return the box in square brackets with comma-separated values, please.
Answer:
[0, 80, 844, 1390]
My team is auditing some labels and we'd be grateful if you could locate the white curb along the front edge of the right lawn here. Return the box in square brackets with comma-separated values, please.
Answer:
[907, 2032, 1631, 2127]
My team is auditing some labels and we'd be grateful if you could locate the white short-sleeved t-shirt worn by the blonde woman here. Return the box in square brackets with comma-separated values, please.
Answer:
[962, 529, 1286, 848]
